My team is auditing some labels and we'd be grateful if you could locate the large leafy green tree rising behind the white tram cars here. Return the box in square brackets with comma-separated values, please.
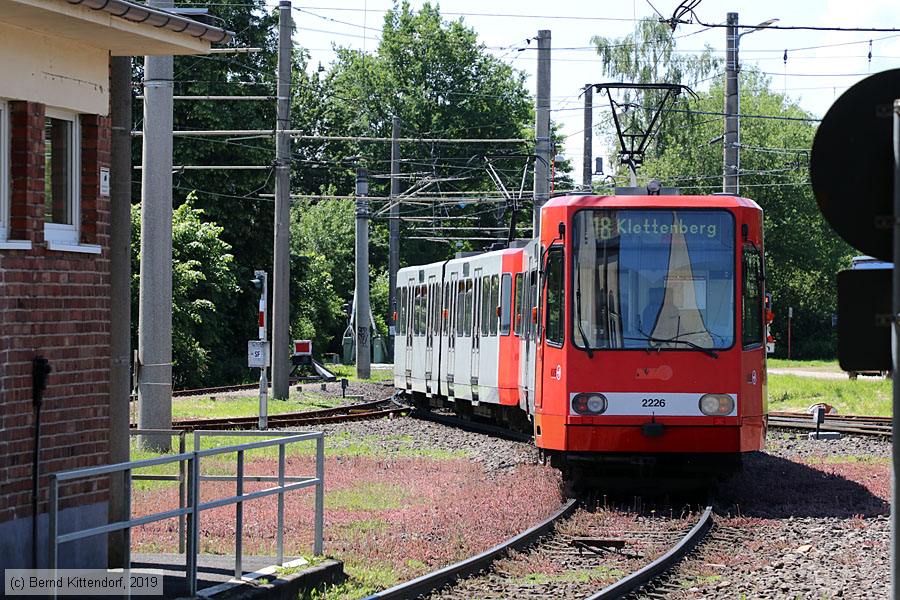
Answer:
[292, 2, 534, 352]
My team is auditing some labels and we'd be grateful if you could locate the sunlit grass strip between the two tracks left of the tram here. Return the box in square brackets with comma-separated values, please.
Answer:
[172, 392, 344, 419]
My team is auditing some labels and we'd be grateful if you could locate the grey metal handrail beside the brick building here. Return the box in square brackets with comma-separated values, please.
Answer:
[48, 430, 325, 596]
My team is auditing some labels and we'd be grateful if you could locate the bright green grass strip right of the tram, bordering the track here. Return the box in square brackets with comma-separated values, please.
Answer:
[769, 374, 892, 416]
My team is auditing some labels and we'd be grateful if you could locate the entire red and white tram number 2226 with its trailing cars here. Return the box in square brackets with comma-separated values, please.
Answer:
[394, 195, 767, 472]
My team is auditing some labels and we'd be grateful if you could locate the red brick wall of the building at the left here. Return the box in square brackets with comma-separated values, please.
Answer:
[0, 102, 110, 523]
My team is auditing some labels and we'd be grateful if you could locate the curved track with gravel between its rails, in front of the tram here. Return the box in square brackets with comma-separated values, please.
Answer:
[367, 500, 712, 600]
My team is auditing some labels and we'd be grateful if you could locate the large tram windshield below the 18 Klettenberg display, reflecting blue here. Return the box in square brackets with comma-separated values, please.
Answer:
[572, 209, 735, 351]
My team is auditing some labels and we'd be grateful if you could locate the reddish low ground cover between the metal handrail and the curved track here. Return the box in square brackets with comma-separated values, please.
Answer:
[132, 456, 562, 578]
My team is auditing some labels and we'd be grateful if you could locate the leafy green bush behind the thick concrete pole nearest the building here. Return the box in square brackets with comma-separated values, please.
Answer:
[131, 196, 236, 387]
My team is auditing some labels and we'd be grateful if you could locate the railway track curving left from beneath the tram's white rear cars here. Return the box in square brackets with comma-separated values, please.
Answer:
[172, 398, 409, 431]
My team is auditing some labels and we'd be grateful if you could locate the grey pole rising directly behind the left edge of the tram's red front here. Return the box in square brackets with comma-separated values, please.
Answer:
[533, 29, 550, 236]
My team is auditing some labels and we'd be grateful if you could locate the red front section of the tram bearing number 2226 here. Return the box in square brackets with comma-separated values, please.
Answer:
[536, 196, 766, 459]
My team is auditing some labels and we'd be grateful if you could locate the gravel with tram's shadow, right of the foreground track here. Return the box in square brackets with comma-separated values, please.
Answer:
[669, 431, 890, 600]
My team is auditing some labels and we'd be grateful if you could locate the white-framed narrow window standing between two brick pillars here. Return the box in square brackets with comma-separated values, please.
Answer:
[44, 109, 80, 245]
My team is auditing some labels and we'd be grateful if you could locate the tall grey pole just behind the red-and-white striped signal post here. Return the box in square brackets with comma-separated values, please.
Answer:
[272, 0, 292, 400]
